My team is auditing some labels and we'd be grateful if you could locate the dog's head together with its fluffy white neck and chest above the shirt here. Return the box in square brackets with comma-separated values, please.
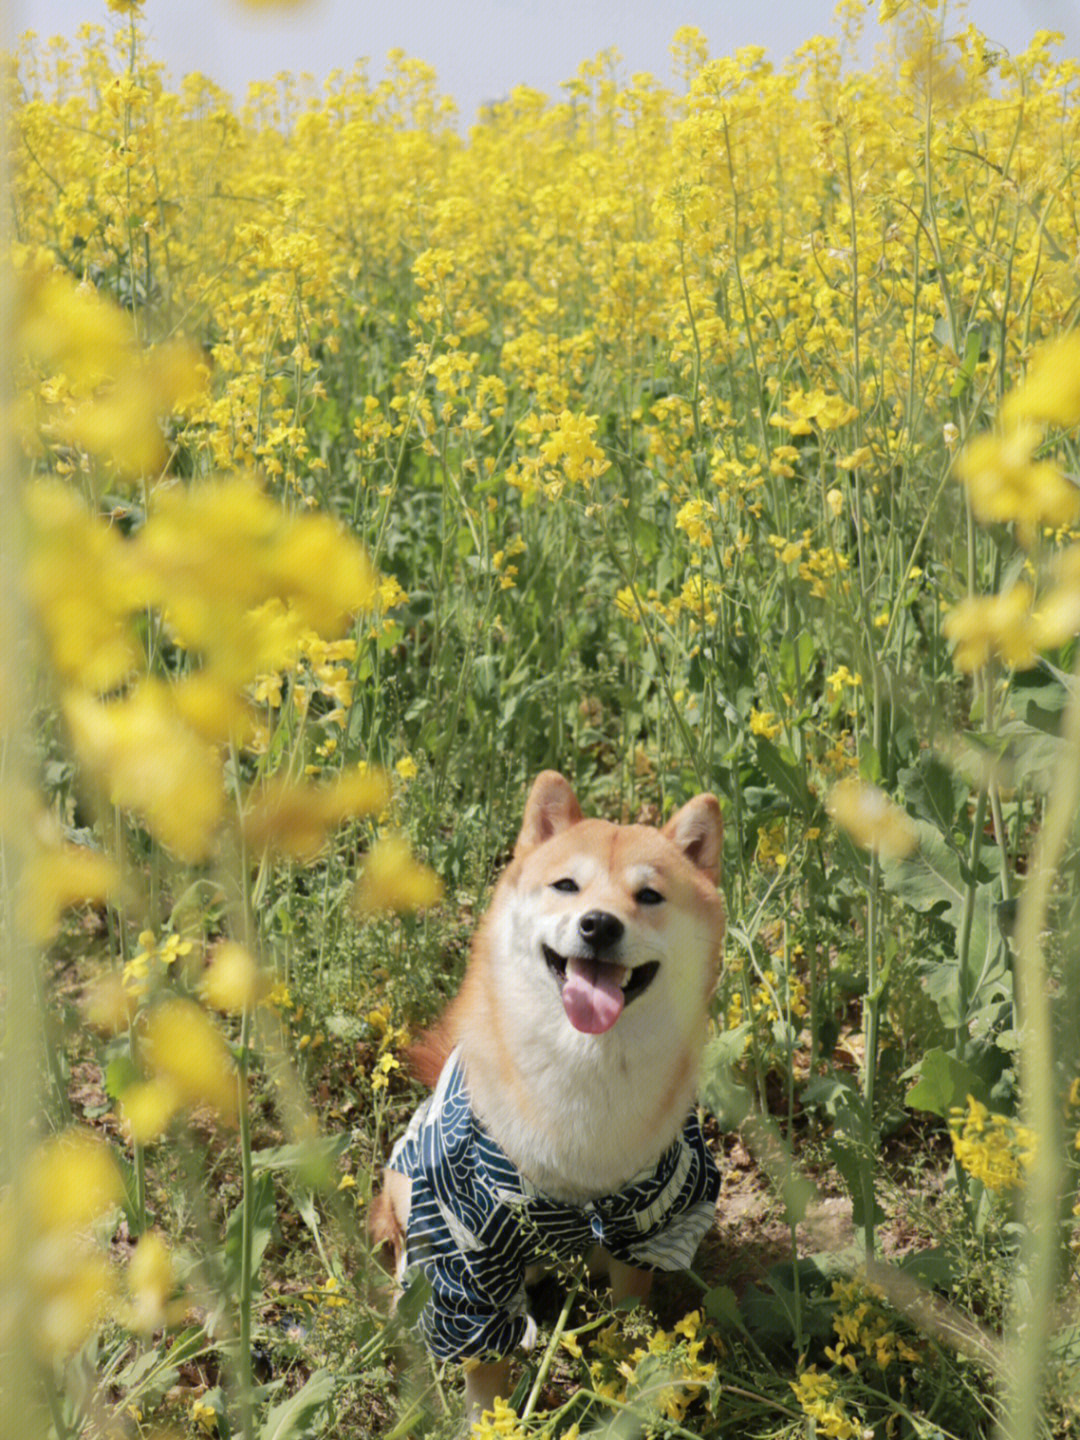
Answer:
[449, 770, 723, 1202]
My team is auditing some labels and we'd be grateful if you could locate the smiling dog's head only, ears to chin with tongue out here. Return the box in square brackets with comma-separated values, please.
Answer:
[501, 772, 723, 1037]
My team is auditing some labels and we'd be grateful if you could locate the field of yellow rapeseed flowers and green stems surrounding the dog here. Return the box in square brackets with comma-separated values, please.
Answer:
[0, 0, 1080, 1440]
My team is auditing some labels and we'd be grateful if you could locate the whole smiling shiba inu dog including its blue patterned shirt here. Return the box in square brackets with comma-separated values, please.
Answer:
[372, 770, 723, 1420]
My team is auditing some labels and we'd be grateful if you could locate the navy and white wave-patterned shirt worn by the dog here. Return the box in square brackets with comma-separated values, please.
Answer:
[389, 1051, 720, 1359]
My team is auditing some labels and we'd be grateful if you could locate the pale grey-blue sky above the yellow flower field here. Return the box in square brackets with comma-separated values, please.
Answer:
[8, 0, 1080, 122]
